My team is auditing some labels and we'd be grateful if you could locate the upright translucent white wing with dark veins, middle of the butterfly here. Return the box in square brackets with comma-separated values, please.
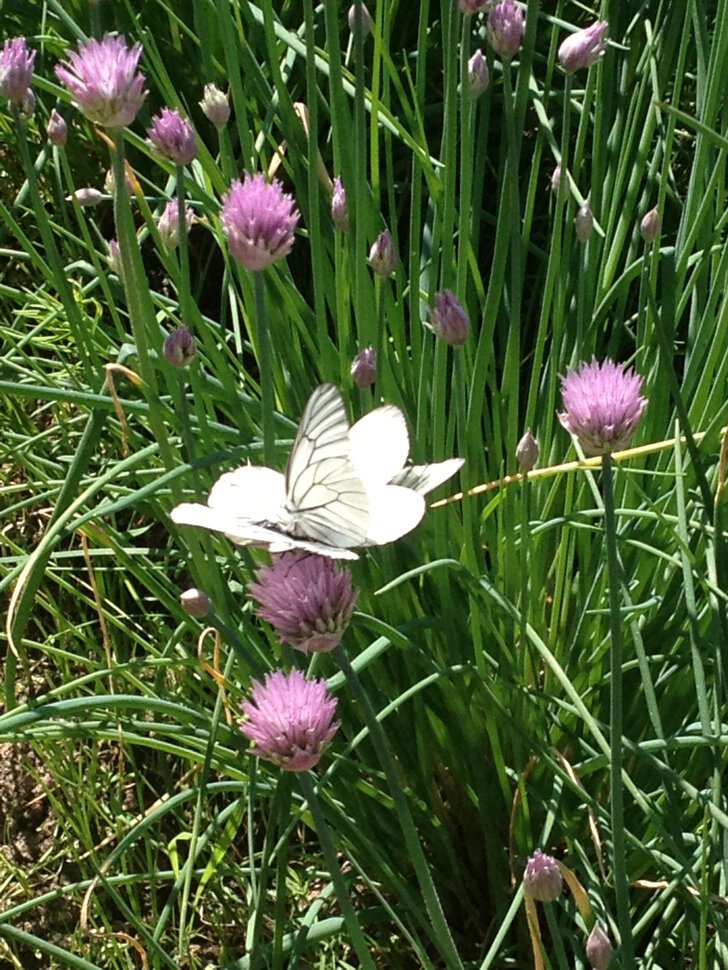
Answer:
[281, 384, 369, 549]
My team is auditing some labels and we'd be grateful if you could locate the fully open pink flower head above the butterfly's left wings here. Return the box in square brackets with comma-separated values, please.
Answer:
[222, 173, 301, 270]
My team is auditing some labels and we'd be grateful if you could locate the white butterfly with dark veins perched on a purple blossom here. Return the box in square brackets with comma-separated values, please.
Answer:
[171, 384, 463, 559]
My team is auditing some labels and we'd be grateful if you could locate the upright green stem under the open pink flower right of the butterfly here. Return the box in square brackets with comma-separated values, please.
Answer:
[602, 454, 636, 970]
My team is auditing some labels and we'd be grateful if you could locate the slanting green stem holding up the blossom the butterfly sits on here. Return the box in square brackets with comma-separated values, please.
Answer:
[334, 645, 463, 970]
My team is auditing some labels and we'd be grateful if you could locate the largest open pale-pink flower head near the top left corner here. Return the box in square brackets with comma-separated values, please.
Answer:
[56, 34, 146, 128]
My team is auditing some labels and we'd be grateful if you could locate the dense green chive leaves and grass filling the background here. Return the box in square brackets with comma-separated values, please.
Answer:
[0, 0, 728, 970]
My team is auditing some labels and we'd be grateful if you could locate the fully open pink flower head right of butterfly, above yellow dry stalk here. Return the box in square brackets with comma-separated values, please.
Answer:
[559, 360, 647, 455]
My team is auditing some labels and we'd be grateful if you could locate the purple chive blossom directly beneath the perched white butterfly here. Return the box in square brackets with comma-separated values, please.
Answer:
[249, 552, 357, 653]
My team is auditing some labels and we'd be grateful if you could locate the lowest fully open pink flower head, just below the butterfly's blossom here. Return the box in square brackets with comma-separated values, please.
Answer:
[240, 670, 339, 771]
